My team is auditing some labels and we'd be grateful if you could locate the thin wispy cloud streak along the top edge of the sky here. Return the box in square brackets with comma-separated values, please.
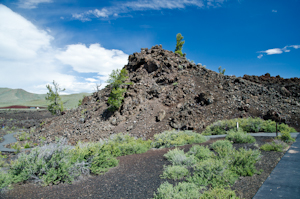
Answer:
[72, 0, 225, 22]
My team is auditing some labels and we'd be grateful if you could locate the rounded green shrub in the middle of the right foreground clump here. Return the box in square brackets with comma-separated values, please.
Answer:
[187, 158, 238, 187]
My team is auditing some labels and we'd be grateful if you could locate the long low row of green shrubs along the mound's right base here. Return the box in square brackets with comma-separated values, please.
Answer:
[203, 117, 296, 135]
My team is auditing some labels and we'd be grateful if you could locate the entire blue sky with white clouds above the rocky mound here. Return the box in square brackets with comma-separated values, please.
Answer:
[0, 0, 300, 93]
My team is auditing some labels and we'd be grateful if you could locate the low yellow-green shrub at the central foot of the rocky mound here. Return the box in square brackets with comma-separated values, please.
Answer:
[151, 130, 208, 148]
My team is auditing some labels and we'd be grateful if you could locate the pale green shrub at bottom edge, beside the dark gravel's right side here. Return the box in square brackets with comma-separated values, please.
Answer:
[154, 182, 201, 199]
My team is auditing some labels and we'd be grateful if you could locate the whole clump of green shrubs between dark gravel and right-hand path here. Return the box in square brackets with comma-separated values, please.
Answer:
[154, 137, 262, 199]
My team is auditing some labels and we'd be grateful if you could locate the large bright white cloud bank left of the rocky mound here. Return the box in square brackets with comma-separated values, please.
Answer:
[0, 4, 127, 93]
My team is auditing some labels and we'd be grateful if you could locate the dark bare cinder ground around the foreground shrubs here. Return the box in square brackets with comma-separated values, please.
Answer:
[0, 137, 284, 199]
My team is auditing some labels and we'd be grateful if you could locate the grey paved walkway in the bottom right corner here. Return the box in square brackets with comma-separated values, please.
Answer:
[253, 135, 300, 199]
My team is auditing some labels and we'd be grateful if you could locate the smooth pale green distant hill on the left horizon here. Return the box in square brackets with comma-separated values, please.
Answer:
[0, 88, 91, 109]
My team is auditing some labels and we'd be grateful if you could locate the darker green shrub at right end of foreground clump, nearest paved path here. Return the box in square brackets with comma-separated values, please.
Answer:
[229, 148, 260, 176]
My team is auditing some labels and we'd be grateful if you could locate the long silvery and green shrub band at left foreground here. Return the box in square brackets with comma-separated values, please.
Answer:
[0, 134, 151, 188]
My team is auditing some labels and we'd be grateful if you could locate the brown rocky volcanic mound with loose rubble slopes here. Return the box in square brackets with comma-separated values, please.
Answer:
[32, 45, 300, 144]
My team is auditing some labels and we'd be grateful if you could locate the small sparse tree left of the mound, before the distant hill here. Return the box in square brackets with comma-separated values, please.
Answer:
[45, 80, 65, 115]
